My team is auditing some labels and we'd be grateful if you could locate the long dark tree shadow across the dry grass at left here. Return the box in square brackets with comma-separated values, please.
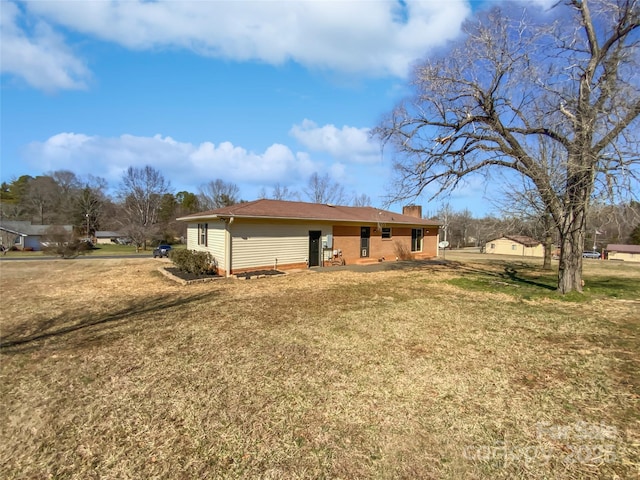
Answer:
[0, 292, 211, 353]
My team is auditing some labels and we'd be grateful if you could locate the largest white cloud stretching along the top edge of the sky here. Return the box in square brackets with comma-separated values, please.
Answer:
[13, 0, 470, 88]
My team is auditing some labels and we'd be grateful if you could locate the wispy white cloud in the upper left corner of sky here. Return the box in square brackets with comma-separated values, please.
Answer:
[0, 1, 90, 91]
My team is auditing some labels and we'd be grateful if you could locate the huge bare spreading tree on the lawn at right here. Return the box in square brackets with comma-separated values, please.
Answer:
[376, 0, 640, 293]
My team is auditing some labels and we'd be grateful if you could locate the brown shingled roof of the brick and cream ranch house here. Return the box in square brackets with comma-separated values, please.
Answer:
[178, 199, 440, 226]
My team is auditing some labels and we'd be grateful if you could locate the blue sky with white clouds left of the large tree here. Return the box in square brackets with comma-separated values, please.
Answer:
[0, 0, 549, 216]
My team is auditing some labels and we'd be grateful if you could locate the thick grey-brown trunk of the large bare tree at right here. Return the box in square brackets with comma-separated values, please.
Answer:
[558, 208, 585, 294]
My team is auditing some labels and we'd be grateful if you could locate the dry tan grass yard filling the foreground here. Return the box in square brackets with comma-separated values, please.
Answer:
[0, 252, 640, 479]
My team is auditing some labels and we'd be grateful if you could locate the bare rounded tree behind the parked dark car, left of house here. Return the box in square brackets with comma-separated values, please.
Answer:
[118, 165, 170, 248]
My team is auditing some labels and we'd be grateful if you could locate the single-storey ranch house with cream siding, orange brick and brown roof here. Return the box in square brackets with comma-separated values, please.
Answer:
[178, 199, 438, 275]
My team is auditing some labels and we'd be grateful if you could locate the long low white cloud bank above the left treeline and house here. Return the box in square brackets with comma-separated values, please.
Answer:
[24, 133, 319, 191]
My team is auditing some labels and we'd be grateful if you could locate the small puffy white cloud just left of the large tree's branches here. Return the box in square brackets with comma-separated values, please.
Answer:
[289, 119, 380, 163]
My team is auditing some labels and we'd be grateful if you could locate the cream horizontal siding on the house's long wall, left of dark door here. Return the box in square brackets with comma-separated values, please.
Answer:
[231, 222, 332, 270]
